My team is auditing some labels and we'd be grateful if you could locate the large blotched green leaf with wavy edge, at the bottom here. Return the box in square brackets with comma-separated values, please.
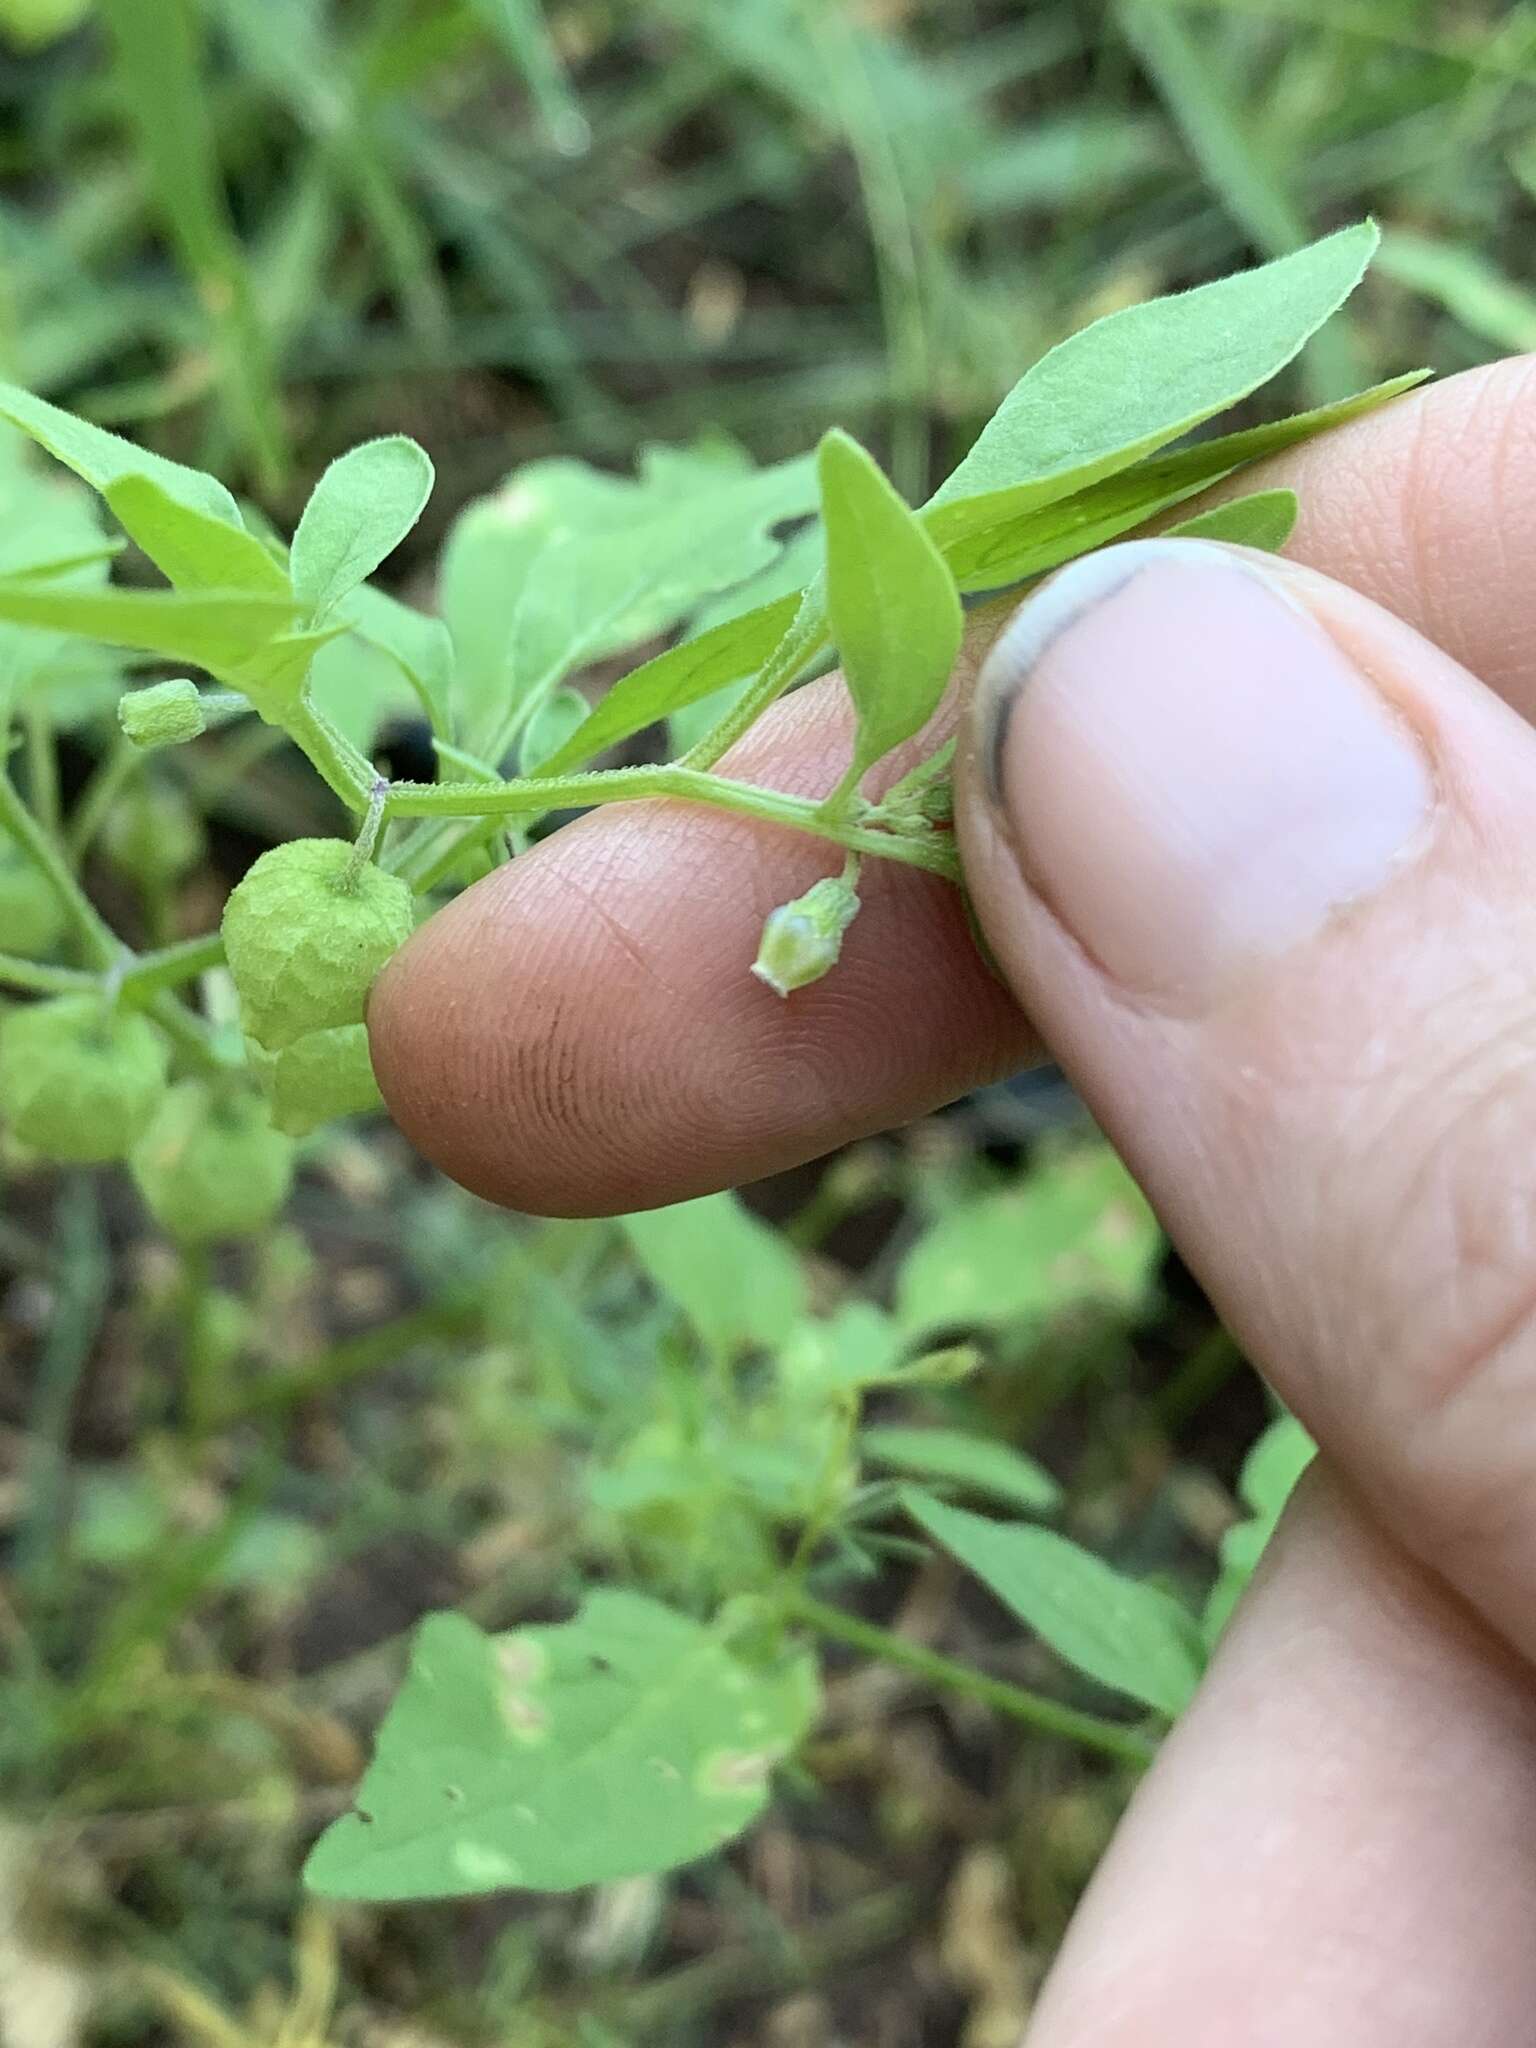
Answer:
[305, 1591, 817, 1898]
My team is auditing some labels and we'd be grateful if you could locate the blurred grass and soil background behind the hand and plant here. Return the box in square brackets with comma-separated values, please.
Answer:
[0, 0, 1536, 2048]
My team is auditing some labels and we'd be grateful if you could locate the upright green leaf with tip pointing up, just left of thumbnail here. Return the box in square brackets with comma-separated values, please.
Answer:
[817, 430, 963, 780]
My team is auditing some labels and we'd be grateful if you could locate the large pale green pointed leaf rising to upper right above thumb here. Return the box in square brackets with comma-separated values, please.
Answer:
[924, 221, 1380, 551]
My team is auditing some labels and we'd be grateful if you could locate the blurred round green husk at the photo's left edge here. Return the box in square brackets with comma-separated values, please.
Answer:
[0, 995, 168, 1165]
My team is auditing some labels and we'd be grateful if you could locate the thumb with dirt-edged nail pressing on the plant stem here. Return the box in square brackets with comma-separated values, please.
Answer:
[961, 541, 1536, 1657]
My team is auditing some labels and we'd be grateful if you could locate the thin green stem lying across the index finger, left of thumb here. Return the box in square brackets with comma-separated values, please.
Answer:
[387, 762, 961, 887]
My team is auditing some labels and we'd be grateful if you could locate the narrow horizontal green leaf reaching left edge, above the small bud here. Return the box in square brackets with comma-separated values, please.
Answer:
[0, 580, 293, 676]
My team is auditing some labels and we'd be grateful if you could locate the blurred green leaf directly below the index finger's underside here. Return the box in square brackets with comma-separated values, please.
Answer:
[623, 1194, 805, 1358]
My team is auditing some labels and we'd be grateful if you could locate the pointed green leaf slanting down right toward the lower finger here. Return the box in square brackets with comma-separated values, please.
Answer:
[903, 1489, 1202, 1718]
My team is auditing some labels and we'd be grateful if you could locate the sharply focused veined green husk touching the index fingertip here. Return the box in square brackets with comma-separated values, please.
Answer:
[223, 840, 416, 1053]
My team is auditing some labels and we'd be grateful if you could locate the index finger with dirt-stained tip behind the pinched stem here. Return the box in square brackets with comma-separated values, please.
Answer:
[369, 356, 1536, 1214]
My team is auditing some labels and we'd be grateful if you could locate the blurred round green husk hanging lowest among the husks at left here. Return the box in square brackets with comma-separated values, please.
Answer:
[129, 1081, 293, 1245]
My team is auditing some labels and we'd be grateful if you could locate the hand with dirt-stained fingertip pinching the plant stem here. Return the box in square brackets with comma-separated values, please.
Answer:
[371, 360, 1536, 2048]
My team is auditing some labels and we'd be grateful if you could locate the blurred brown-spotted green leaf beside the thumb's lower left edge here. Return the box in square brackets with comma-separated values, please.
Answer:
[897, 1145, 1163, 1333]
